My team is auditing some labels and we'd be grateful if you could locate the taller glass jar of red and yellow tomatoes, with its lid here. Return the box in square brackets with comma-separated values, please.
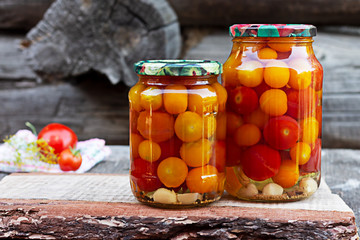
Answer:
[222, 24, 323, 202]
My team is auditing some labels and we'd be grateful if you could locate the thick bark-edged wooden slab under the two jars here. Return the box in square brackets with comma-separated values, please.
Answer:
[0, 174, 357, 239]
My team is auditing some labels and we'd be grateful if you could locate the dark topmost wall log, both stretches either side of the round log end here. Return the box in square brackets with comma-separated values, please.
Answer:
[0, 0, 360, 30]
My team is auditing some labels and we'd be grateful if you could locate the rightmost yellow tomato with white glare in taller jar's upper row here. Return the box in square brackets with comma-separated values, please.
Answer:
[289, 58, 312, 89]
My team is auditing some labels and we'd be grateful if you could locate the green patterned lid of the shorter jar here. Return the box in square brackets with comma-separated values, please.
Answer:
[134, 60, 222, 76]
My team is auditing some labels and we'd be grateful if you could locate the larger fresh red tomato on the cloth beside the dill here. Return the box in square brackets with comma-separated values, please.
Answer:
[38, 123, 78, 154]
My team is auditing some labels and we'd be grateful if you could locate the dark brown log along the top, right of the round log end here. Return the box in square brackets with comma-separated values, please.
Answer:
[169, 0, 360, 27]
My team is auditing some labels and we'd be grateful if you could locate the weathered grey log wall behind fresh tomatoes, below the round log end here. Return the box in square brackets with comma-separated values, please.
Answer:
[0, 70, 129, 144]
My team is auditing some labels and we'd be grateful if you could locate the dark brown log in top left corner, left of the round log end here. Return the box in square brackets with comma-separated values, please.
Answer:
[0, 0, 54, 30]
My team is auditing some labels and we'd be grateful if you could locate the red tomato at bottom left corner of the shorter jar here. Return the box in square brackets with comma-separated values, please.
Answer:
[130, 158, 162, 192]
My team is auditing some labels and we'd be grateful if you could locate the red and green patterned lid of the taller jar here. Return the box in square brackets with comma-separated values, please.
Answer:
[229, 24, 316, 37]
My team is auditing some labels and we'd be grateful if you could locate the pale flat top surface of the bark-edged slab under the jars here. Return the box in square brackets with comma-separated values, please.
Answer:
[0, 173, 353, 213]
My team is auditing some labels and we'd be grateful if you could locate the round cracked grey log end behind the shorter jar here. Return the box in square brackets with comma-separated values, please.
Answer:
[22, 0, 181, 86]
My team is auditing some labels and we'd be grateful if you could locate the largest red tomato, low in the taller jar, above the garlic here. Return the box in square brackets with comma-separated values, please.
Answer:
[241, 144, 281, 181]
